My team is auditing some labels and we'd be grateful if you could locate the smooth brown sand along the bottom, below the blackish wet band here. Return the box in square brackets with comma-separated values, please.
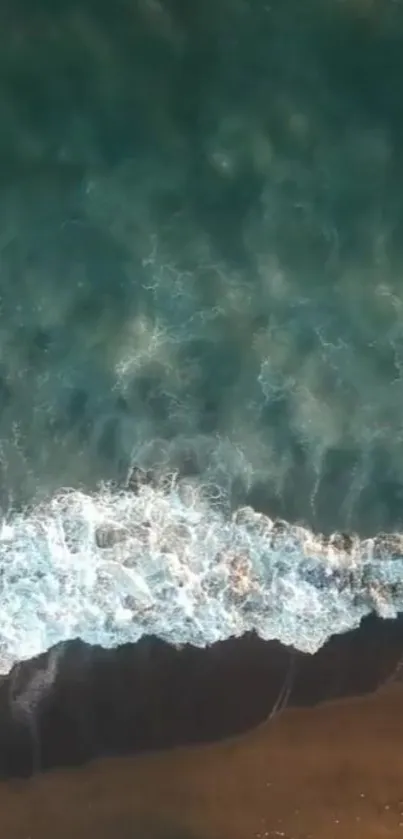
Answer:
[0, 685, 403, 839]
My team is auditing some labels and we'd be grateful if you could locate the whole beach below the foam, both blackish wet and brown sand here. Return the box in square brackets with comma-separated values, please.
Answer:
[0, 618, 403, 839]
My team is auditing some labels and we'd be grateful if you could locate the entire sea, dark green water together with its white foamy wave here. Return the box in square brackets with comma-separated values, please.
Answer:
[0, 0, 403, 670]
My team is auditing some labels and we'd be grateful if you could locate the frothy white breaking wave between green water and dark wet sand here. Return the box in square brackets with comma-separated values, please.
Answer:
[0, 472, 403, 672]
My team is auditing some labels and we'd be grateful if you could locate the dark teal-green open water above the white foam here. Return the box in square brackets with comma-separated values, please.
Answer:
[0, 0, 403, 668]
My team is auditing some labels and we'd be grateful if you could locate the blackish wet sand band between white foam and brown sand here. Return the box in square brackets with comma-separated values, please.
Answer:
[0, 616, 403, 779]
